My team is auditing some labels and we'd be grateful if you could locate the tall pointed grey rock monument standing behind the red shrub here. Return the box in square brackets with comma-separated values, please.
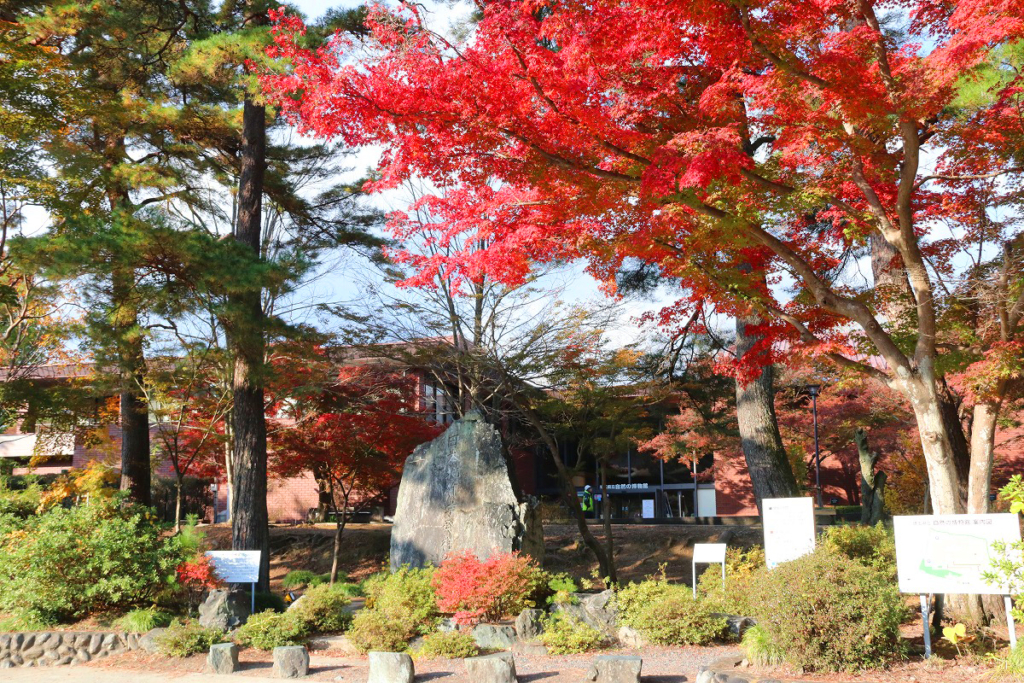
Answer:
[391, 412, 544, 571]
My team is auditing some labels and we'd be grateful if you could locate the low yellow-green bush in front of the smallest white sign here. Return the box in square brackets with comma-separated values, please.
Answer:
[615, 579, 726, 645]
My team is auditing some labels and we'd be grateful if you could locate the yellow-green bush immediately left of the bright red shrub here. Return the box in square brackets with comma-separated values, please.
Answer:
[348, 567, 438, 652]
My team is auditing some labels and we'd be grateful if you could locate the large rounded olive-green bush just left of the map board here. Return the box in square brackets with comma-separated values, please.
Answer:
[752, 546, 907, 671]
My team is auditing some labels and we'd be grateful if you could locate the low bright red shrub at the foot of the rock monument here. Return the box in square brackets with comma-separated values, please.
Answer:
[433, 551, 545, 625]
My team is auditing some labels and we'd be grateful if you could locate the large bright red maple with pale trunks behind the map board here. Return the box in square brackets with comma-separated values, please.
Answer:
[263, 0, 1024, 513]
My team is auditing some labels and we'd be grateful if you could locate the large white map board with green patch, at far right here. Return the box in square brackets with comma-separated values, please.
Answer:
[893, 514, 1021, 595]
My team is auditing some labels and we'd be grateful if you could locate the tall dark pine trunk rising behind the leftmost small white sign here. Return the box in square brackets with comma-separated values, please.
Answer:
[230, 99, 270, 591]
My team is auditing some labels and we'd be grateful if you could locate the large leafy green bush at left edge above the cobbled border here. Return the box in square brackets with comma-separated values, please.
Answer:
[0, 497, 194, 623]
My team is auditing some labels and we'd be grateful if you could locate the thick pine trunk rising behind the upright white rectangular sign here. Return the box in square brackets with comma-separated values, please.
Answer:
[736, 314, 800, 511]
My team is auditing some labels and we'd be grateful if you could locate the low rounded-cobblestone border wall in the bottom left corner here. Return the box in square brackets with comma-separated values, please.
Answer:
[0, 631, 142, 669]
